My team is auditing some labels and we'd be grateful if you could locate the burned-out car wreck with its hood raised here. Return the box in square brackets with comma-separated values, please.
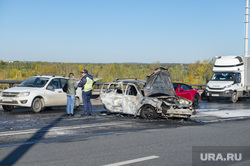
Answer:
[100, 67, 193, 119]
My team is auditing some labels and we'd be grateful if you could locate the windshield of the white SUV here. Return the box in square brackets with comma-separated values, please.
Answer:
[18, 77, 49, 88]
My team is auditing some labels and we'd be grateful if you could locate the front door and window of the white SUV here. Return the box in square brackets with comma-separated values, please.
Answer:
[45, 78, 67, 106]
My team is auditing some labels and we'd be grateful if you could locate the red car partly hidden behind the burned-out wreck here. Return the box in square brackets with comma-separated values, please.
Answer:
[173, 83, 201, 106]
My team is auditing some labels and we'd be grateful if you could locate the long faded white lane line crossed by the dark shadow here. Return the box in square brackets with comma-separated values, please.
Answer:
[0, 122, 131, 137]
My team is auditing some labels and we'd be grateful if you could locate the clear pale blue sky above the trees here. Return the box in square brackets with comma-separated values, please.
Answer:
[0, 0, 246, 63]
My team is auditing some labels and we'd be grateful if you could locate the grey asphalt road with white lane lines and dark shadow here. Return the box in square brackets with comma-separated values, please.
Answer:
[0, 100, 250, 166]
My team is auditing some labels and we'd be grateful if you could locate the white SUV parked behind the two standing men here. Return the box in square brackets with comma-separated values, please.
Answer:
[0, 76, 82, 112]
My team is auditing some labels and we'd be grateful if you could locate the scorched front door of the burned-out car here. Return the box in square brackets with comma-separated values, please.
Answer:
[123, 83, 143, 115]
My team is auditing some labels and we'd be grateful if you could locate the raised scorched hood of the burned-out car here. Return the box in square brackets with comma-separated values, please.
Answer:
[144, 67, 176, 97]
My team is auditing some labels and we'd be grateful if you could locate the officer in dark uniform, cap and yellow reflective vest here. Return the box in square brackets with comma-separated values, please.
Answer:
[78, 69, 94, 115]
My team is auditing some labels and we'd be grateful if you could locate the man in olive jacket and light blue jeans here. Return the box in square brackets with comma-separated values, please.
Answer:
[66, 73, 77, 116]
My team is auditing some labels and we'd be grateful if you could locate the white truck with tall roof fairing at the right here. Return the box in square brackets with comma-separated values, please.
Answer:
[204, 56, 250, 103]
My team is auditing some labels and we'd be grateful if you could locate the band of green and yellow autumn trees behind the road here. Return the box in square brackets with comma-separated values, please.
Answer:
[0, 59, 214, 88]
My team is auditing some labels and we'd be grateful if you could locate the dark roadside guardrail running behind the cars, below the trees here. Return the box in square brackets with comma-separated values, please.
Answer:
[0, 80, 206, 90]
